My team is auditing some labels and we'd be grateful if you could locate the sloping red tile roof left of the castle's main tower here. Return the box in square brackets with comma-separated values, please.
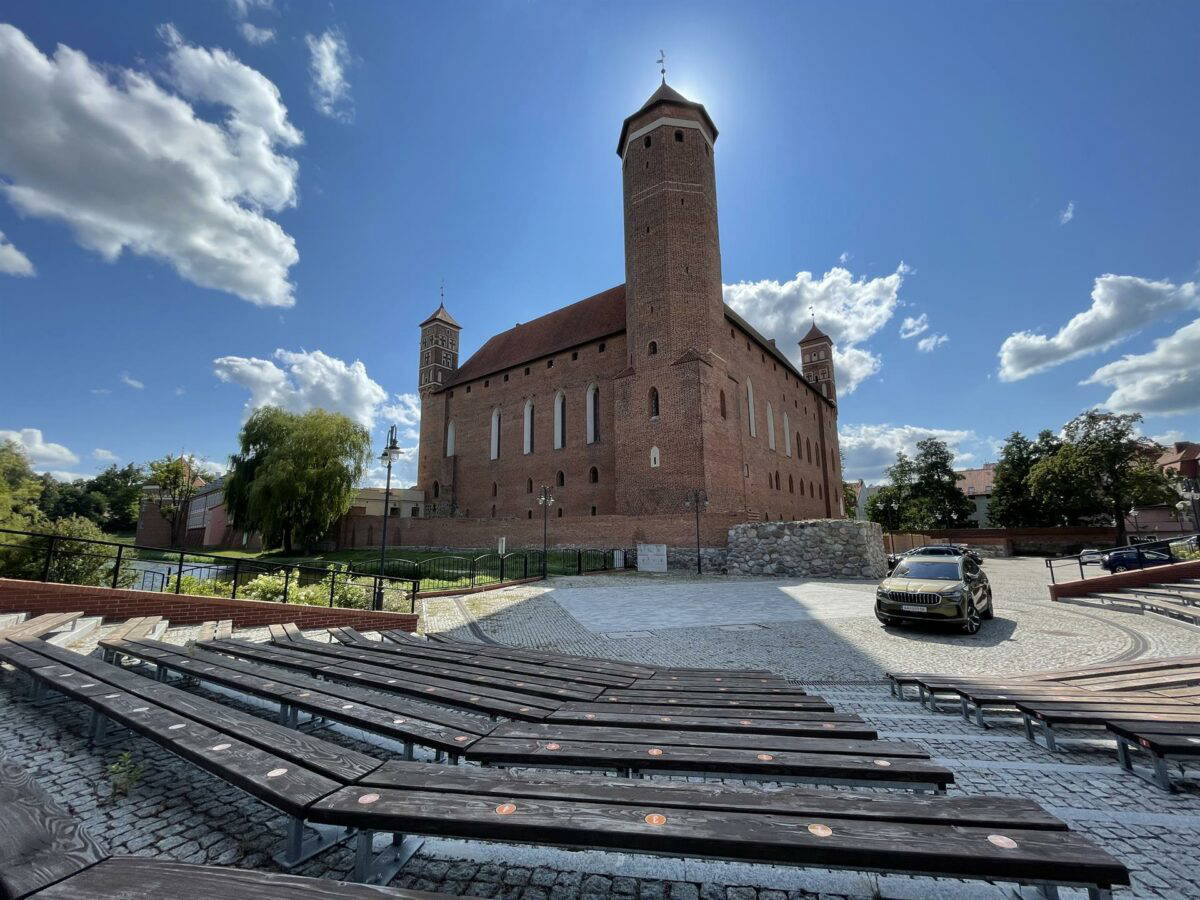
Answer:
[445, 284, 625, 388]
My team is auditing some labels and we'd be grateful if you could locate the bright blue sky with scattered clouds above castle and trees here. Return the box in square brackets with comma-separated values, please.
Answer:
[0, 0, 1200, 480]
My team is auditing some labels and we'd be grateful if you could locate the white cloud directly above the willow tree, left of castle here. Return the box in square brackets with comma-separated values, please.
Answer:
[212, 349, 388, 428]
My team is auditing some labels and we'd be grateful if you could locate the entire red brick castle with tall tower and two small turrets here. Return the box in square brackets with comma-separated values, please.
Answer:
[417, 80, 842, 546]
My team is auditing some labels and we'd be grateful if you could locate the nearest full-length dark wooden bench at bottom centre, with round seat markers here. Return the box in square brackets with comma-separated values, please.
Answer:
[314, 763, 1129, 898]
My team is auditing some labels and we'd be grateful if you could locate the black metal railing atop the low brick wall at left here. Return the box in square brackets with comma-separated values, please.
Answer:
[0, 528, 419, 612]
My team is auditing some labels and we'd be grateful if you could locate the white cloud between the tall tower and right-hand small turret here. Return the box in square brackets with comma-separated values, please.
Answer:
[724, 263, 910, 396]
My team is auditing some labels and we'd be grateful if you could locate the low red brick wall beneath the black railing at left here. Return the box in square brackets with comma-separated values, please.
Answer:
[0, 578, 418, 631]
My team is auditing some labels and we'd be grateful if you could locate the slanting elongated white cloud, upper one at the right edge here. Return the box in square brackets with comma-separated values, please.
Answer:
[1000, 275, 1200, 382]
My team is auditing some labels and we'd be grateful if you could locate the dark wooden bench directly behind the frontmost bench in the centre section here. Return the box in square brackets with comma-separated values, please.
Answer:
[464, 737, 954, 793]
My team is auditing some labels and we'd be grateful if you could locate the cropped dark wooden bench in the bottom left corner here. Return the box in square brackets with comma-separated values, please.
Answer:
[0, 757, 463, 900]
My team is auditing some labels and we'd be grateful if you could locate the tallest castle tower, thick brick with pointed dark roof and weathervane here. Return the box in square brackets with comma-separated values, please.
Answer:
[614, 84, 725, 515]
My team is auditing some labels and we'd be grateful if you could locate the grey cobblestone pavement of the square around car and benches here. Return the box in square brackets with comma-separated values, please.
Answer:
[7, 559, 1200, 900]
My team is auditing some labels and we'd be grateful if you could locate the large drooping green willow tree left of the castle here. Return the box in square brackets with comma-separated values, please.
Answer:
[226, 407, 371, 553]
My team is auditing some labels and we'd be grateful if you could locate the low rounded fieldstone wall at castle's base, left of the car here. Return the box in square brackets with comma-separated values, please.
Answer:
[726, 518, 887, 578]
